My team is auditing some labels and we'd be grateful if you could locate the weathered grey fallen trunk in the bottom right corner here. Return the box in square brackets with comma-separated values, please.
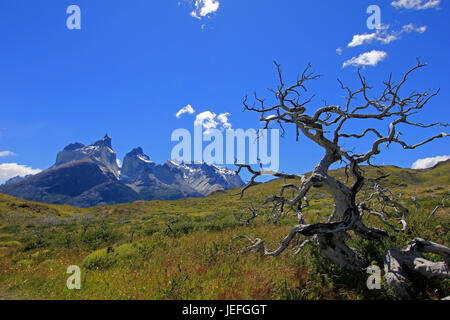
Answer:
[384, 238, 450, 299]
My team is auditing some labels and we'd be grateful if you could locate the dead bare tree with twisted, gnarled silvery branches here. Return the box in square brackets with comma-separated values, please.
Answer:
[236, 60, 448, 296]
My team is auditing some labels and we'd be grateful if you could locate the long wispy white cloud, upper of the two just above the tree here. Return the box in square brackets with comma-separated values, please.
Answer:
[347, 23, 427, 48]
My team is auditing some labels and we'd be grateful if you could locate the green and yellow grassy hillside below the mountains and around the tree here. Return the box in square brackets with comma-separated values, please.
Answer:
[0, 162, 450, 299]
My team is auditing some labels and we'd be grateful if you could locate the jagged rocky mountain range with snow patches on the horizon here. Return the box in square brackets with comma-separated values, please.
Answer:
[0, 135, 243, 207]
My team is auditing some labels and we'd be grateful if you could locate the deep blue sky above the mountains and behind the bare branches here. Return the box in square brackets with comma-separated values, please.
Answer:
[0, 0, 450, 180]
